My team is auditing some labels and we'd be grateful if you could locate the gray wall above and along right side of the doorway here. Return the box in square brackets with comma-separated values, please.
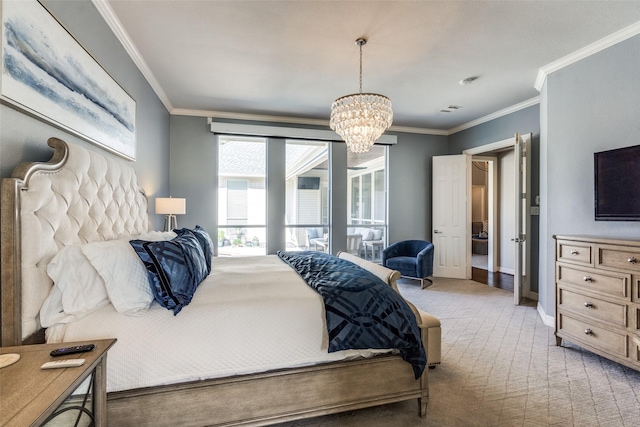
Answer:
[449, 105, 540, 292]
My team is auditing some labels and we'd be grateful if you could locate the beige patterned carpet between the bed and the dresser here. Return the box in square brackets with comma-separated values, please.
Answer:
[274, 279, 640, 427]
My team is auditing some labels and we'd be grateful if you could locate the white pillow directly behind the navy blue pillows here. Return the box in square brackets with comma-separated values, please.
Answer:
[82, 231, 176, 316]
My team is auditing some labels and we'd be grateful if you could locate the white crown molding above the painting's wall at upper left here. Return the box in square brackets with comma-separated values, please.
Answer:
[91, 0, 173, 113]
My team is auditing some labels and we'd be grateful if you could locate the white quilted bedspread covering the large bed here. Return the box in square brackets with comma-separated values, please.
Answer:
[47, 255, 385, 391]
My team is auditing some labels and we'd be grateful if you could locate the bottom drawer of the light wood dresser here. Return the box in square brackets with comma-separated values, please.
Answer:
[558, 313, 628, 357]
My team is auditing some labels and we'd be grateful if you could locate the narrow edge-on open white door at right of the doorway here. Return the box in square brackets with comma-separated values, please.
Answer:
[511, 134, 531, 305]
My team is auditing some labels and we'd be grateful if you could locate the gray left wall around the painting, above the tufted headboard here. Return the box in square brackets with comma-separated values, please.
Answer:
[0, 0, 169, 228]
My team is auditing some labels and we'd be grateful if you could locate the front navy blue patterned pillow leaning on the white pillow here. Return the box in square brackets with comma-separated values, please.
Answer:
[129, 232, 209, 315]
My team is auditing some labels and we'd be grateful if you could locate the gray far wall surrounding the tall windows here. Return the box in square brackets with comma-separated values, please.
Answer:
[170, 116, 448, 252]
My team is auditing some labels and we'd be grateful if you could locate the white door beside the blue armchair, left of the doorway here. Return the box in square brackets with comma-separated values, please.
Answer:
[431, 154, 471, 279]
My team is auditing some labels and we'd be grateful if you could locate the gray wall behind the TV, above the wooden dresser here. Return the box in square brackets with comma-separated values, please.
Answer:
[539, 36, 640, 315]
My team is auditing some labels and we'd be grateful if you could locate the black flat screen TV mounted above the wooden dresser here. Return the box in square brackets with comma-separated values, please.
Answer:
[594, 145, 640, 221]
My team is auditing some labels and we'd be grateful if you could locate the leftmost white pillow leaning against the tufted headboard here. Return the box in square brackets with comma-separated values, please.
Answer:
[40, 246, 109, 328]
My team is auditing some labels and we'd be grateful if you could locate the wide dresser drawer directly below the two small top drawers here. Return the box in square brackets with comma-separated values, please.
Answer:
[556, 263, 631, 300]
